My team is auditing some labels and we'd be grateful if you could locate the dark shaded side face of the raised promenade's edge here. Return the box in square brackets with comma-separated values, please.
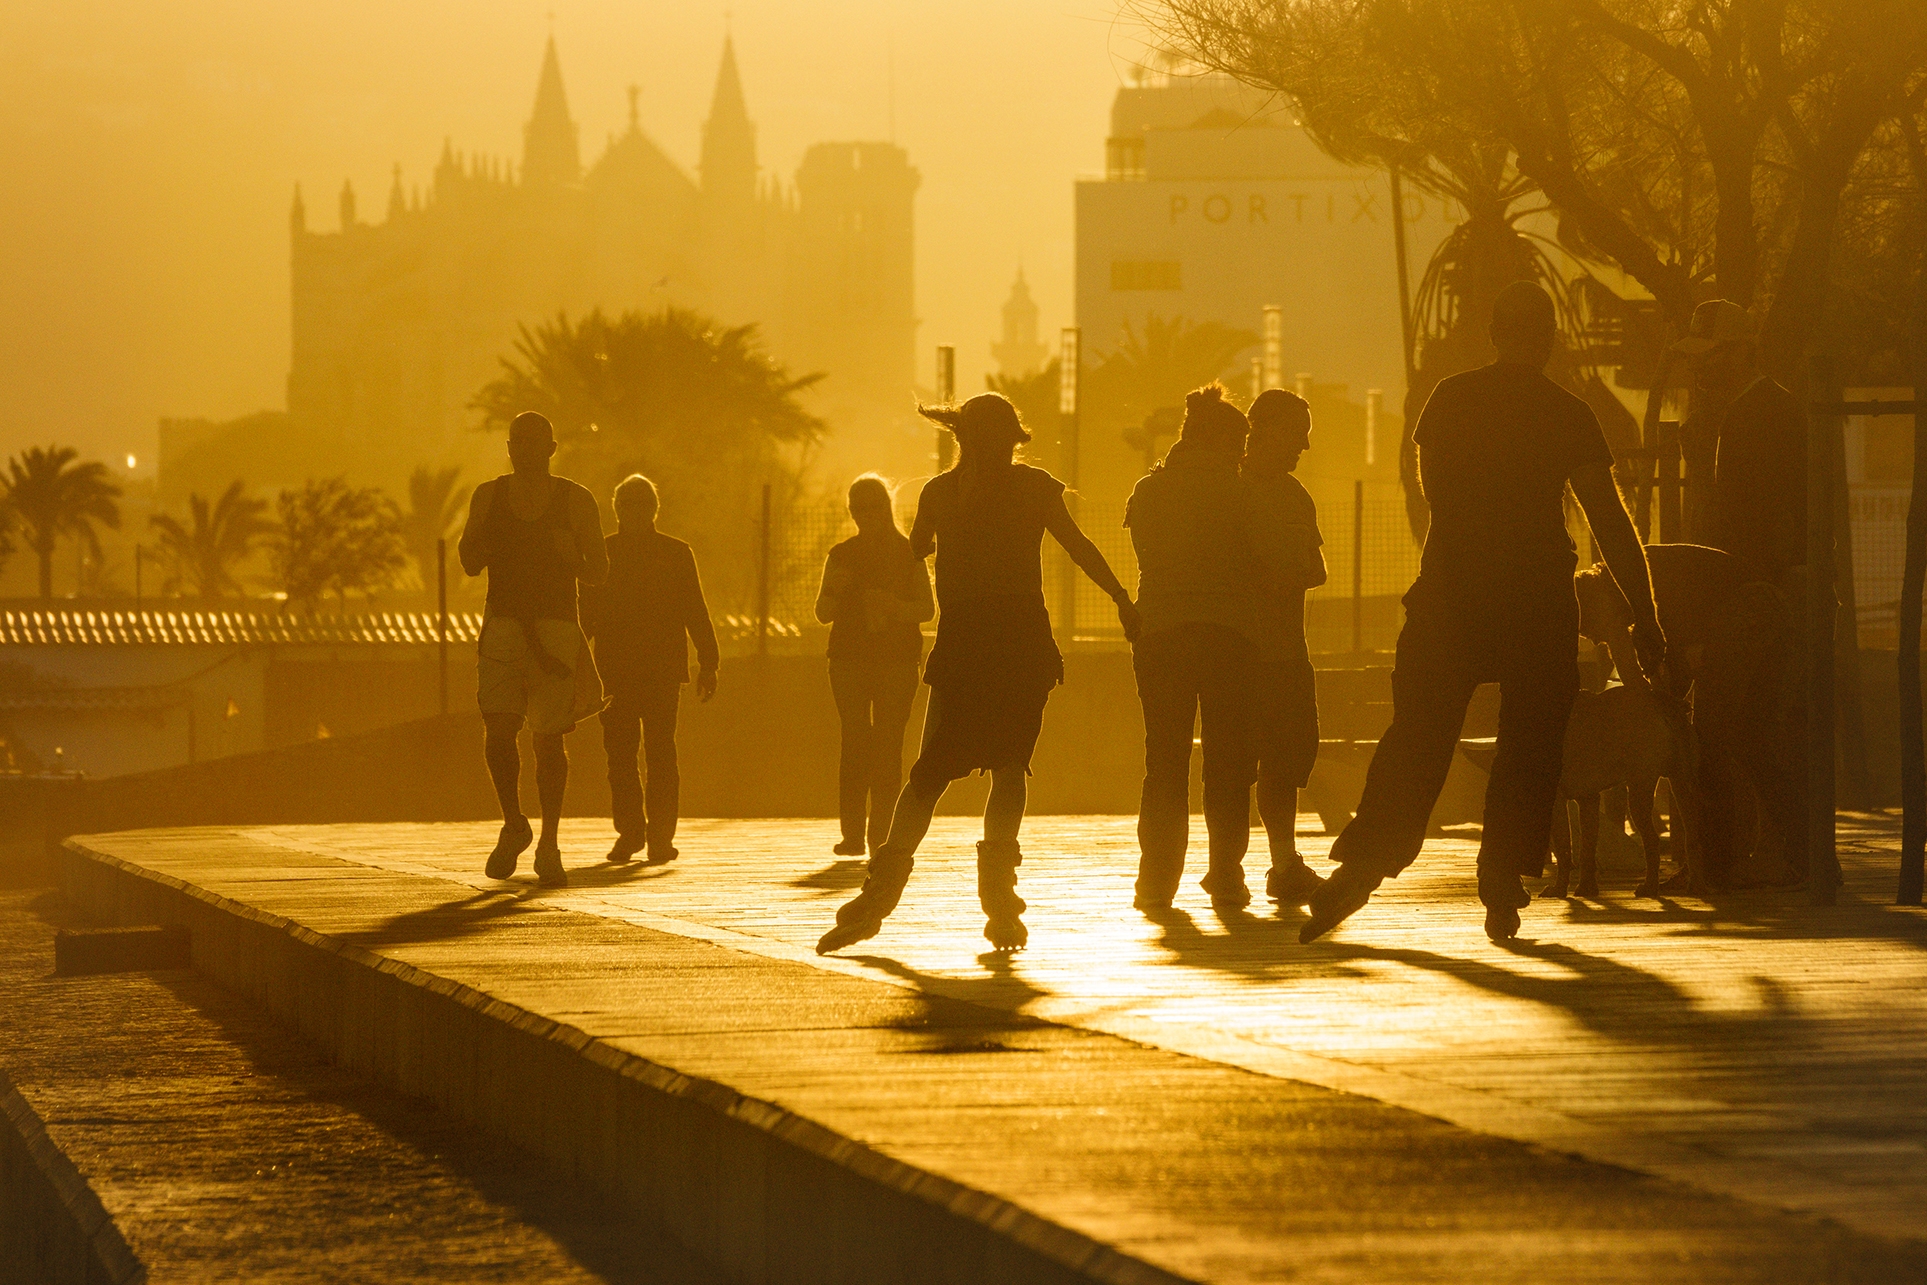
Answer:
[60, 838, 1183, 1285]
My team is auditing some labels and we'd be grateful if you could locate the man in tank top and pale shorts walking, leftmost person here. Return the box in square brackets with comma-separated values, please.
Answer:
[459, 410, 609, 888]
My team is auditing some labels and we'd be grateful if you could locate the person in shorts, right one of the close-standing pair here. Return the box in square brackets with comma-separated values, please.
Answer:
[1243, 389, 1326, 905]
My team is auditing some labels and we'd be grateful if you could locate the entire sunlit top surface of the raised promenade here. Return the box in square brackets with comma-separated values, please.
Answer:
[52, 817, 1927, 1281]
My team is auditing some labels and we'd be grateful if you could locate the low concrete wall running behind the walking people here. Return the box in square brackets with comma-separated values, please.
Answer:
[11, 651, 1518, 861]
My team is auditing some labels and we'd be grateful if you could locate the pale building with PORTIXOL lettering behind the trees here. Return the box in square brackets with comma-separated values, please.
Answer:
[1075, 77, 1453, 499]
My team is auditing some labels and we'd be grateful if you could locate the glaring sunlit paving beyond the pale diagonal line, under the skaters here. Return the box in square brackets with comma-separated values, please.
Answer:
[258, 817, 1927, 1235]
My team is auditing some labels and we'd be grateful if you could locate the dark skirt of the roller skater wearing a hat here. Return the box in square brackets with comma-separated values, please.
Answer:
[917, 595, 1064, 780]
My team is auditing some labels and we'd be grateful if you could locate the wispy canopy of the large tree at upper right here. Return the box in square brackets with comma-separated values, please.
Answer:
[1129, 0, 1927, 381]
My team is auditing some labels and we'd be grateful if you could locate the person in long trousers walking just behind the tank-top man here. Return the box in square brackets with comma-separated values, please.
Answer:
[582, 474, 717, 865]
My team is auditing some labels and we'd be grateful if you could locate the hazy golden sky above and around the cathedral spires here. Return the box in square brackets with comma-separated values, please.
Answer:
[0, 0, 1139, 464]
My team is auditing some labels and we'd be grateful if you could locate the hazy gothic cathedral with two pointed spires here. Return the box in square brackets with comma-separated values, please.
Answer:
[279, 40, 923, 484]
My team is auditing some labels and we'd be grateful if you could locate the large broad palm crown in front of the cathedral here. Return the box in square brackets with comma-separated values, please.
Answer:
[472, 308, 825, 608]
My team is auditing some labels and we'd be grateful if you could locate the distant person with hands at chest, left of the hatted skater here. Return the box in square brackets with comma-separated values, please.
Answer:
[817, 474, 937, 857]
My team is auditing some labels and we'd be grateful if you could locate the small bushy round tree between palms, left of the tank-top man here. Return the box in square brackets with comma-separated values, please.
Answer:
[270, 478, 407, 611]
